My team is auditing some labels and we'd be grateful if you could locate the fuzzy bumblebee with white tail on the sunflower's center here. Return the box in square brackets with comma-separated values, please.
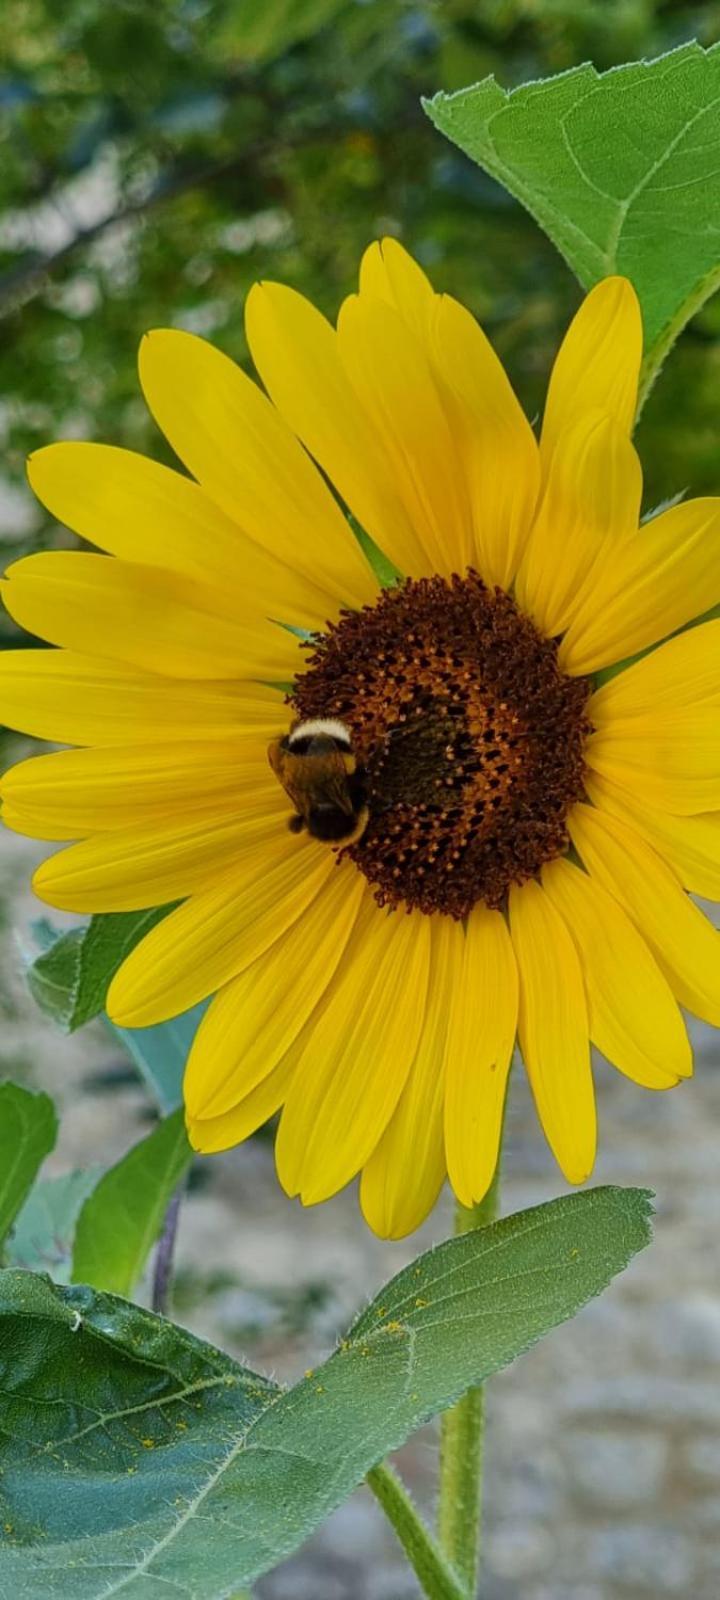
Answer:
[267, 717, 368, 845]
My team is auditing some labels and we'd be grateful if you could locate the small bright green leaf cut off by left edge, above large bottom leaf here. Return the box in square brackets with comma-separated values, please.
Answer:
[0, 1083, 58, 1245]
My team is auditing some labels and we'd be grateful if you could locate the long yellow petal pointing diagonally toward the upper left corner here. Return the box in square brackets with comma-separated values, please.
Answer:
[139, 328, 378, 605]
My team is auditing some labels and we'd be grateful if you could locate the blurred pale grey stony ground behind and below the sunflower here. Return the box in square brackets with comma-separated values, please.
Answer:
[0, 834, 720, 1600]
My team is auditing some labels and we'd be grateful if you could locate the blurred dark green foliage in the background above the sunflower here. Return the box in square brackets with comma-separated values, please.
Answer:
[0, 0, 720, 645]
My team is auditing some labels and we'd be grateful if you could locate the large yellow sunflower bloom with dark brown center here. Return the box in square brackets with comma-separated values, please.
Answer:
[0, 240, 720, 1237]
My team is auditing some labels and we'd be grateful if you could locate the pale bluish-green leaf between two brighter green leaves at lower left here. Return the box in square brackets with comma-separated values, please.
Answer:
[6, 1166, 102, 1283]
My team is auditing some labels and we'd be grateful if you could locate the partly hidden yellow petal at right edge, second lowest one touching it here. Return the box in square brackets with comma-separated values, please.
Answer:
[586, 773, 720, 899]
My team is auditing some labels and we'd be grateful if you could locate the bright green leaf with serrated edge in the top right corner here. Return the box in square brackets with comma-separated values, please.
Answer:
[424, 43, 720, 403]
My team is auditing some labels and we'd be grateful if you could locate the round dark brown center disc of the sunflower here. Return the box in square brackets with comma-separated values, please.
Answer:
[293, 570, 590, 917]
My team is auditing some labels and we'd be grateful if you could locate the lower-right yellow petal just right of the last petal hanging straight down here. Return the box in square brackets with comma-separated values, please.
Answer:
[542, 861, 693, 1090]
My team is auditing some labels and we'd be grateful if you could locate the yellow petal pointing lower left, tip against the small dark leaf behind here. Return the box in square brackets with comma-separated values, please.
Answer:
[107, 829, 340, 1027]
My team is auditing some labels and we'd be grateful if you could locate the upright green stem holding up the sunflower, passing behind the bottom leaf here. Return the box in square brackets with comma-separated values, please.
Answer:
[438, 1162, 499, 1600]
